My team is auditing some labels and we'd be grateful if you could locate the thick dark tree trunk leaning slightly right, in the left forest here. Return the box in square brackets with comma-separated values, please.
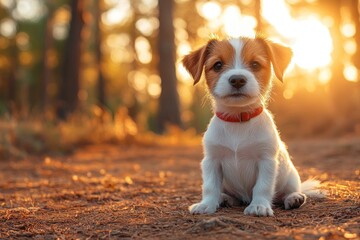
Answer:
[58, 0, 84, 119]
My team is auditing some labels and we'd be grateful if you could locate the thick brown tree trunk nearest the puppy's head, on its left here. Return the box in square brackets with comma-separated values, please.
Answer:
[158, 0, 181, 132]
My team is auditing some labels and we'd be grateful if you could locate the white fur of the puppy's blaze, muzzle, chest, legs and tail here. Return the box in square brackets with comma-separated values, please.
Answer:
[189, 39, 319, 216]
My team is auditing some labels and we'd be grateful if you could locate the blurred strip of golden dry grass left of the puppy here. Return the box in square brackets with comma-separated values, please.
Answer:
[0, 106, 201, 158]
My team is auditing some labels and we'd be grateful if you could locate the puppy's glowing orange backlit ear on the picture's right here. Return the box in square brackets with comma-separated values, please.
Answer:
[265, 40, 293, 82]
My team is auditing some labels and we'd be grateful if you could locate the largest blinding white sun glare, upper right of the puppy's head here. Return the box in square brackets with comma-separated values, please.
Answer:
[262, 0, 333, 71]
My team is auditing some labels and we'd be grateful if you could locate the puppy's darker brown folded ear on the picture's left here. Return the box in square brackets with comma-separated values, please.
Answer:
[182, 39, 217, 85]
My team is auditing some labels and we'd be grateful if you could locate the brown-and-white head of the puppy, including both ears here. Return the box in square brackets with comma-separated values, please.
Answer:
[182, 37, 292, 107]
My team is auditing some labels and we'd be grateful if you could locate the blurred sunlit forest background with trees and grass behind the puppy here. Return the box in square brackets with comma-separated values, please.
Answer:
[0, 0, 360, 156]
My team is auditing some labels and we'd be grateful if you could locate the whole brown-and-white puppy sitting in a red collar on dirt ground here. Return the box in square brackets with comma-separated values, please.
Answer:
[182, 37, 322, 216]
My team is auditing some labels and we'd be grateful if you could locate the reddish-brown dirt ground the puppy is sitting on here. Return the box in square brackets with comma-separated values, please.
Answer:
[0, 138, 360, 240]
